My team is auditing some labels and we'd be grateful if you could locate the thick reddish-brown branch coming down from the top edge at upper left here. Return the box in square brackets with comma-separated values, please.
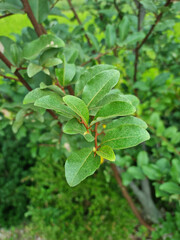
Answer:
[21, 0, 46, 37]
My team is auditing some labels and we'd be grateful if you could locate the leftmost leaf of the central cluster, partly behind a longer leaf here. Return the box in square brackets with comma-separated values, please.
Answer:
[23, 88, 51, 104]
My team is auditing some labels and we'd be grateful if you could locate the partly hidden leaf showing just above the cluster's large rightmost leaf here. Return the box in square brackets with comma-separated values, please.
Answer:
[106, 116, 147, 131]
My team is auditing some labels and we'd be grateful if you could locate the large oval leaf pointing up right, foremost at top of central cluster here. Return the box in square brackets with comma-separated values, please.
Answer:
[82, 70, 120, 107]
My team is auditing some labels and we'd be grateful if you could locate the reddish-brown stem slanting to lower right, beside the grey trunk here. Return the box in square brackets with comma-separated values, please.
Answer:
[111, 163, 154, 231]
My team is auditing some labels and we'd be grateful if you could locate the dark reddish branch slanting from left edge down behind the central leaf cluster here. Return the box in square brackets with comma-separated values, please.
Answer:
[0, 52, 62, 127]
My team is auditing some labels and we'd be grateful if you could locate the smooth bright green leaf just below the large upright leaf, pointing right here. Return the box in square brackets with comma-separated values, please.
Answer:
[92, 101, 136, 124]
